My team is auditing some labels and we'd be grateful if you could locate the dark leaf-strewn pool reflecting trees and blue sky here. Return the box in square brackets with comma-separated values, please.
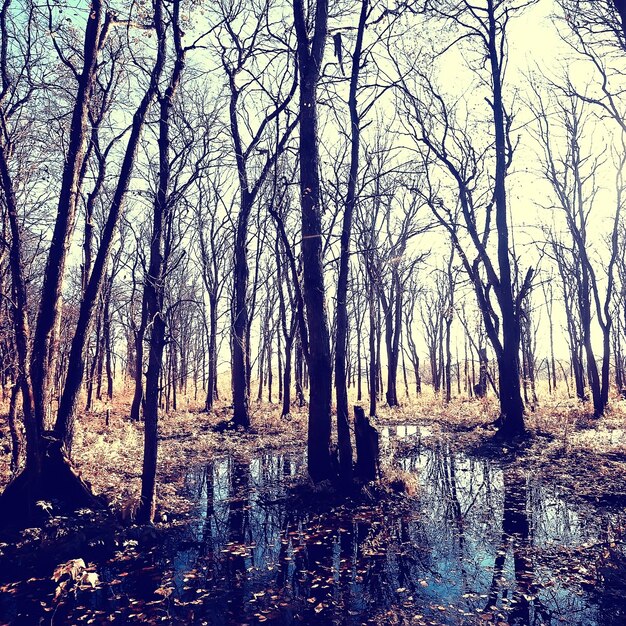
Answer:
[0, 427, 626, 626]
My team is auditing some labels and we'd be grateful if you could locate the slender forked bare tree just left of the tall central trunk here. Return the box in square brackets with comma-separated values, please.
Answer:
[218, 2, 297, 428]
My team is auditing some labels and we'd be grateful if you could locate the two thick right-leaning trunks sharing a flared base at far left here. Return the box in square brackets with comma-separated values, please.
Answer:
[2, 1, 166, 517]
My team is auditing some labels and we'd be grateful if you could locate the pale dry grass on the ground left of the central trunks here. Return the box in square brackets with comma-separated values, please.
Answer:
[0, 386, 306, 513]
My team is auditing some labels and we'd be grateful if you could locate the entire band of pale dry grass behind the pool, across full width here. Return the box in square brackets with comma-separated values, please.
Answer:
[0, 382, 626, 512]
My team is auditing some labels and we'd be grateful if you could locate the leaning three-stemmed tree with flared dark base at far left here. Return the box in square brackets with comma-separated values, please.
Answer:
[0, 0, 166, 522]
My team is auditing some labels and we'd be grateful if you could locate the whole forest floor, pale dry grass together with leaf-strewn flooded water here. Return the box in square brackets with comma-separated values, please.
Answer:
[0, 393, 626, 626]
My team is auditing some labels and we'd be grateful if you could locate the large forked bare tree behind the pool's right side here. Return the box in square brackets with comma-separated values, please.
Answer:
[398, 0, 533, 438]
